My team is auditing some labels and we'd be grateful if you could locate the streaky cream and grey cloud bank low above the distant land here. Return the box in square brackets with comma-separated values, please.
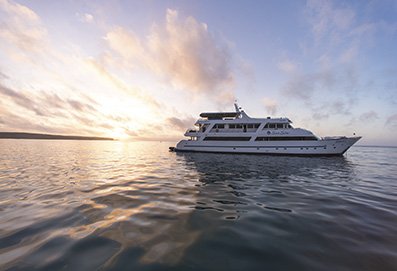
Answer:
[0, 78, 130, 135]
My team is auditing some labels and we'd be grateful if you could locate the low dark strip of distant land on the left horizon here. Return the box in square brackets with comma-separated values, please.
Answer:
[0, 132, 114, 140]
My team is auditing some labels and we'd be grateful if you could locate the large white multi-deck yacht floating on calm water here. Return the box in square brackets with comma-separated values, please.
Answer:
[170, 104, 361, 156]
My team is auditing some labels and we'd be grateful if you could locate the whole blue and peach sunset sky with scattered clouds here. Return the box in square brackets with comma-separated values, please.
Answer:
[0, 0, 397, 146]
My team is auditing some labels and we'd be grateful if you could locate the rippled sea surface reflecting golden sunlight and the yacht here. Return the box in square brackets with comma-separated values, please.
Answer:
[0, 139, 397, 271]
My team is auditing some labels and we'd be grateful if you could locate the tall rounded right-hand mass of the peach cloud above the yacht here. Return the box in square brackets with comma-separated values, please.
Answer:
[148, 10, 234, 92]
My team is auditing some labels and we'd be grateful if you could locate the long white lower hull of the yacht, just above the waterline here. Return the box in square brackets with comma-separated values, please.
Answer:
[173, 137, 361, 156]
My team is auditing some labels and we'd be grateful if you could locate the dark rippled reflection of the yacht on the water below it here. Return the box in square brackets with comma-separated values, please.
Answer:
[177, 152, 354, 218]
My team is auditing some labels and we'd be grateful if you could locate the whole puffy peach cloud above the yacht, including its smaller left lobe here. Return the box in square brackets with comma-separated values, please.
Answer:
[105, 9, 235, 100]
